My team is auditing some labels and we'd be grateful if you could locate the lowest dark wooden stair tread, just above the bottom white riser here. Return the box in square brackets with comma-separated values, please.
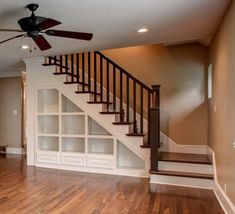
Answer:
[150, 170, 213, 179]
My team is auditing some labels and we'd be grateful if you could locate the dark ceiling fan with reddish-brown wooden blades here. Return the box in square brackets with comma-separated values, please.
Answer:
[0, 4, 93, 51]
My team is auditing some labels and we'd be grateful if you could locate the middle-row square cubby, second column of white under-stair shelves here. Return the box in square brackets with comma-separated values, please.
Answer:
[61, 115, 85, 135]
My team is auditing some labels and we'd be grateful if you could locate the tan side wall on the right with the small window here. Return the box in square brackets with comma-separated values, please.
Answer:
[209, 1, 235, 204]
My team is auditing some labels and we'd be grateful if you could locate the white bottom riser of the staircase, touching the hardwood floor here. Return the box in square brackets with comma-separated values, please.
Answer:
[150, 175, 215, 189]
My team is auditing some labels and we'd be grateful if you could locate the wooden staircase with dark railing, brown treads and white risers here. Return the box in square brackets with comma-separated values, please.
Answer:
[40, 51, 213, 188]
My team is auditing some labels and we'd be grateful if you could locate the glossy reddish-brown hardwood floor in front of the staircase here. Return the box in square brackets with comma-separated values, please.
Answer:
[0, 155, 223, 214]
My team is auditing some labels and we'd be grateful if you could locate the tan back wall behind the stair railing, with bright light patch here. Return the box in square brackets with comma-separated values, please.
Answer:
[102, 44, 208, 144]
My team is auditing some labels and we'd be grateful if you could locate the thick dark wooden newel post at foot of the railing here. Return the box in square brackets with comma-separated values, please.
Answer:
[149, 85, 160, 171]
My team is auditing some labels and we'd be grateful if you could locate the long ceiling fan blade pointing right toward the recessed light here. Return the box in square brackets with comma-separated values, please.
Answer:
[45, 30, 93, 41]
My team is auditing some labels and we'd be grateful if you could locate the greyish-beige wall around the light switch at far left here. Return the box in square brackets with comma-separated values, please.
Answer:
[0, 77, 21, 148]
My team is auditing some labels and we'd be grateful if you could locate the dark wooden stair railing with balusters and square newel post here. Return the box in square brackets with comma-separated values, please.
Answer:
[44, 51, 160, 170]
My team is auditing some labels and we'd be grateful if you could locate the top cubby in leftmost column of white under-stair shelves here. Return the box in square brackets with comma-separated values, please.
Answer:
[37, 89, 59, 113]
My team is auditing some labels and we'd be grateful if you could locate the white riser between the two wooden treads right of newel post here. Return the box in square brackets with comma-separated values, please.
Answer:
[158, 161, 213, 175]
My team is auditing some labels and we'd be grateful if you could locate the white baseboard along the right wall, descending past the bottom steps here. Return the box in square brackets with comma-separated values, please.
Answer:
[208, 146, 235, 214]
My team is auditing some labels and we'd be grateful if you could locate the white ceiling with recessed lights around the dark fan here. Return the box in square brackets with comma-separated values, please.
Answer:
[0, 0, 230, 71]
